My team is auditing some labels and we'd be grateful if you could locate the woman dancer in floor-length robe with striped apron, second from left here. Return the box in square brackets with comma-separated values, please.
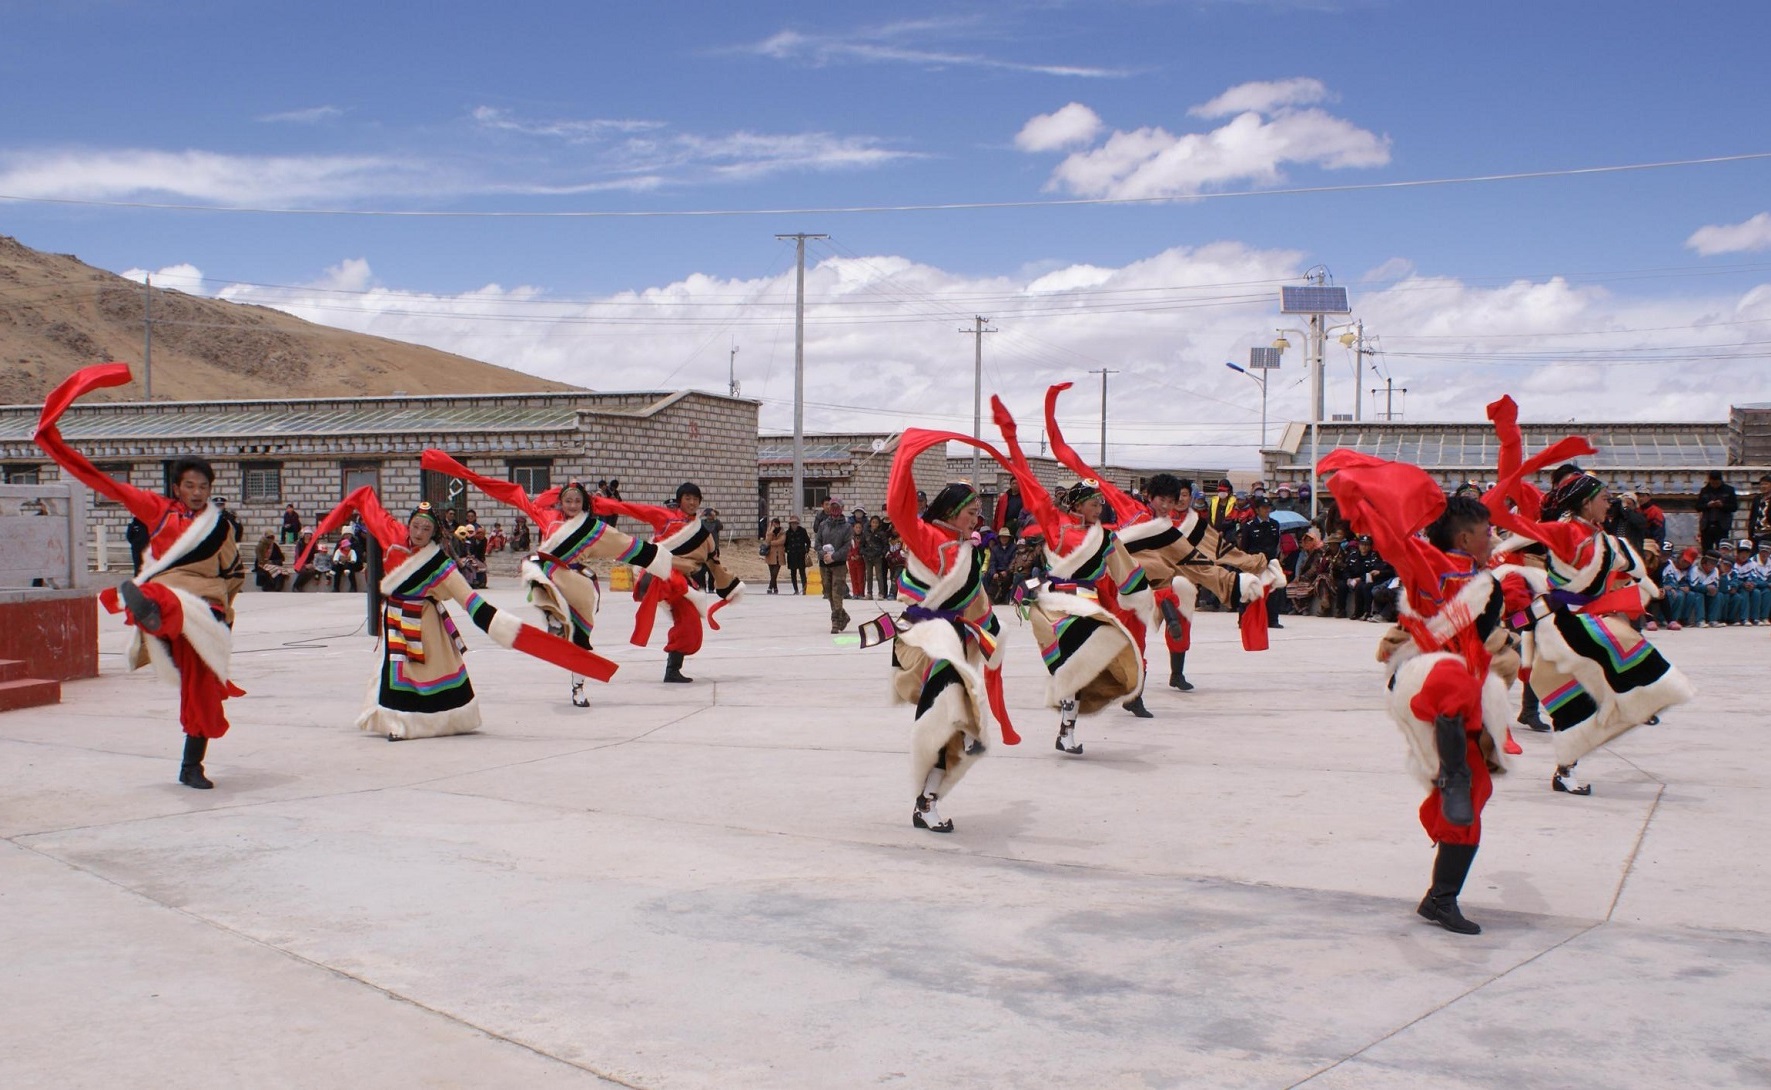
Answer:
[298, 486, 615, 741]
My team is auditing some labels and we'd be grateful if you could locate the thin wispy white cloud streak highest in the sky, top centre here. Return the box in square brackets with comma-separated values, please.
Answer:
[735, 19, 1128, 80]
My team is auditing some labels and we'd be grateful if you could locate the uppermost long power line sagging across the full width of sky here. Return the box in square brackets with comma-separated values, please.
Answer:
[0, 151, 1771, 220]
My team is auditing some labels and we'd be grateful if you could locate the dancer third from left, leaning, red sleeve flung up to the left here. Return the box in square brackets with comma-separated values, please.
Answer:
[418, 450, 671, 707]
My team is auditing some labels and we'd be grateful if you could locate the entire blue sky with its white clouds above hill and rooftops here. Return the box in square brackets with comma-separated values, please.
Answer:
[0, 0, 1771, 464]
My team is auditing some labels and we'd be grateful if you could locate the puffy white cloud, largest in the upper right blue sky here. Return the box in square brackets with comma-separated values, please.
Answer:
[1022, 80, 1390, 200]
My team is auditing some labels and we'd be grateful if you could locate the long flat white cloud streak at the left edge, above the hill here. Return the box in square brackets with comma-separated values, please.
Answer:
[0, 149, 439, 204]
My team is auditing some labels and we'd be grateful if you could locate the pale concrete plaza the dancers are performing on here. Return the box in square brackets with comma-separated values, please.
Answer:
[0, 591, 1771, 1090]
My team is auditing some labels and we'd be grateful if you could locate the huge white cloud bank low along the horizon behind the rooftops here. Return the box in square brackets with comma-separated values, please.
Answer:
[193, 241, 1771, 468]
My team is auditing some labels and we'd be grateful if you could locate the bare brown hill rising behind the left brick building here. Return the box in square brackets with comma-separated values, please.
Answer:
[0, 236, 576, 404]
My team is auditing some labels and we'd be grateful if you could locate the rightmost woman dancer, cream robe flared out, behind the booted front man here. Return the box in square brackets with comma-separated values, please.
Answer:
[1484, 397, 1695, 796]
